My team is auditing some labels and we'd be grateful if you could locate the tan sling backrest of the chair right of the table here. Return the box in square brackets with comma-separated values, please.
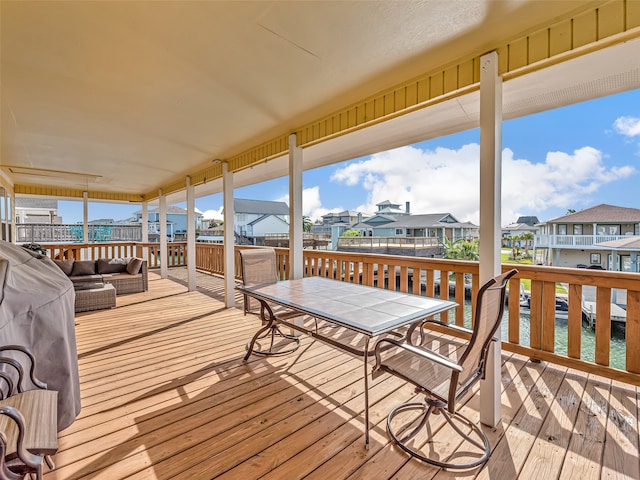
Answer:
[449, 269, 518, 402]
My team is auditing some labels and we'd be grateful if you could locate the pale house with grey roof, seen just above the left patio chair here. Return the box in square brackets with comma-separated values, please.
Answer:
[233, 198, 289, 245]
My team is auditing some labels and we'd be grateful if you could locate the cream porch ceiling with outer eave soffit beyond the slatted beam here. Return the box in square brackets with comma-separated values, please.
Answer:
[0, 0, 640, 201]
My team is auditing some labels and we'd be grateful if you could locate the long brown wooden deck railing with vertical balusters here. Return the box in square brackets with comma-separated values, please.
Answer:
[37, 242, 640, 385]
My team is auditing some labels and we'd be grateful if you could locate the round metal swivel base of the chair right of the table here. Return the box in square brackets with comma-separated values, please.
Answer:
[387, 398, 491, 470]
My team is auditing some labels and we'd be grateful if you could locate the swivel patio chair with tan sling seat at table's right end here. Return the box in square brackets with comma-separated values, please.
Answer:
[373, 270, 517, 469]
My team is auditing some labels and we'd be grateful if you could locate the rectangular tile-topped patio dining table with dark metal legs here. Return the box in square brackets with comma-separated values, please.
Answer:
[236, 277, 456, 449]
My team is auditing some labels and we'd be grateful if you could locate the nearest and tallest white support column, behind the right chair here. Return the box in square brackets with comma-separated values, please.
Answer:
[480, 52, 502, 427]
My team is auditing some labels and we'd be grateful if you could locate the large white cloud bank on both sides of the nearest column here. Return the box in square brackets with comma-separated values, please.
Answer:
[332, 144, 635, 224]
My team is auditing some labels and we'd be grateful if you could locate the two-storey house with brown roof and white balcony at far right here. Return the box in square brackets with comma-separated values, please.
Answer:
[535, 204, 640, 271]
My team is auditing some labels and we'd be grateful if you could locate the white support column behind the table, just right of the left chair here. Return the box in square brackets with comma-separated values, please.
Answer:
[288, 134, 304, 280]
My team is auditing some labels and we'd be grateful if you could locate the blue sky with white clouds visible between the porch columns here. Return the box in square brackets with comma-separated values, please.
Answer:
[59, 90, 640, 225]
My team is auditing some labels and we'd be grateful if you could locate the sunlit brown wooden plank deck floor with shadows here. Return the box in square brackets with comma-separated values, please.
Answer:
[45, 271, 640, 480]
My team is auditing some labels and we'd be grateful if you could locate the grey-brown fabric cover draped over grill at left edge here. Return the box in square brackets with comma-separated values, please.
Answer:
[0, 241, 80, 430]
